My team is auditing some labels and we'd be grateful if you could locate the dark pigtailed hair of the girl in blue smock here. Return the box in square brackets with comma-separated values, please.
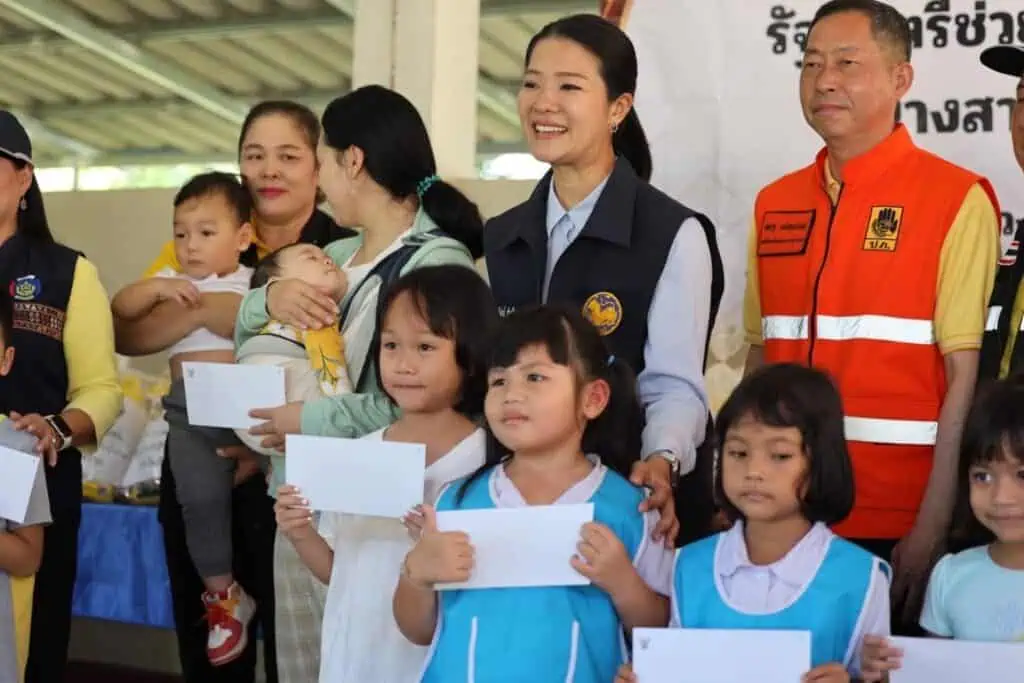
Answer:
[456, 305, 643, 503]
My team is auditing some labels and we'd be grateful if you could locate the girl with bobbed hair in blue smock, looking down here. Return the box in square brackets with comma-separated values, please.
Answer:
[617, 364, 890, 683]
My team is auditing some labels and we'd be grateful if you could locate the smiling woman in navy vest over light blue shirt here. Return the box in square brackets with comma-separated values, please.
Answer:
[484, 14, 723, 542]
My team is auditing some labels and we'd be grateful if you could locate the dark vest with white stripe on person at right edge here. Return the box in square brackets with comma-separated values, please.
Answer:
[978, 216, 1024, 382]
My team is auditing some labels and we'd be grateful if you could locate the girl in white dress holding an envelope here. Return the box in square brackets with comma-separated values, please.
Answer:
[274, 265, 498, 683]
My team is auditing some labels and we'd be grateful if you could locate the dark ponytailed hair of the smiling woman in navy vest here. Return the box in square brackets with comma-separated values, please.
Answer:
[526, 14, 652, 180]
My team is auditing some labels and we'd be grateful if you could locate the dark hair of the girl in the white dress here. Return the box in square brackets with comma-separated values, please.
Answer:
[370, 265, 499, 420]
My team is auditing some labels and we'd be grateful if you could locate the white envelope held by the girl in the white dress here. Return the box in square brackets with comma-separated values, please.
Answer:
[285, 434, 427, 519]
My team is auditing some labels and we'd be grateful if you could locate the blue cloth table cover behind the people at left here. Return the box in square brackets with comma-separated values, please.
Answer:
[72, 503, 174, 629]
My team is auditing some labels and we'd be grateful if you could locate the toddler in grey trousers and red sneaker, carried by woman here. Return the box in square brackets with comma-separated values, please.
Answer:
[112, 172, 256, 666]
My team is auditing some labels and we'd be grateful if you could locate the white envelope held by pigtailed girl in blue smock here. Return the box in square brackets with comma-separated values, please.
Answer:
[437, 503, 594, 591]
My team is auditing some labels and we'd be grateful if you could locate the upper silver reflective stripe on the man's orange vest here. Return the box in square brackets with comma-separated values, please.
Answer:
[761, 315, 935, 345]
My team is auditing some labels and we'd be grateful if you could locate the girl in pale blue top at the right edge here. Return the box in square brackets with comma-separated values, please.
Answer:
[864, 375, 1024, 682]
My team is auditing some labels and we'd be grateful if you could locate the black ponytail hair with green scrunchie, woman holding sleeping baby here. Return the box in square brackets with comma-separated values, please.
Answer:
[323, 85, 483, 259]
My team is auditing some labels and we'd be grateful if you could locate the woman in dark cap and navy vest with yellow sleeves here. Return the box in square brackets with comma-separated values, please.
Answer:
[0, 111, 121, 683]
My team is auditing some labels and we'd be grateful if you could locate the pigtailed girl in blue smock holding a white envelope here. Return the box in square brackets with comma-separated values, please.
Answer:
[394, 307, 672, 683]
